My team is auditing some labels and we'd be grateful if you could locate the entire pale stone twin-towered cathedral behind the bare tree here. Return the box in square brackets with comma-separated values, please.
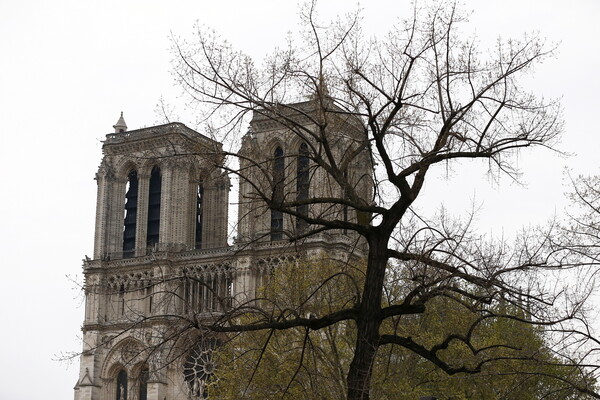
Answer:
[75, 102, 372, 400]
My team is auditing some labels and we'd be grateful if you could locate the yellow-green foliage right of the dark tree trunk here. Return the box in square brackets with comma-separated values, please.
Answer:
[372, 297, 590, 400]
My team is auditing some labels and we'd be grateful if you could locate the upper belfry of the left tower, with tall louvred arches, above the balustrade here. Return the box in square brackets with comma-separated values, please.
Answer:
[94, 113, 229, 259]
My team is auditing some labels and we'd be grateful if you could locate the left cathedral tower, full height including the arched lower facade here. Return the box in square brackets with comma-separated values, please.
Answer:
[75, 113, 231, 400]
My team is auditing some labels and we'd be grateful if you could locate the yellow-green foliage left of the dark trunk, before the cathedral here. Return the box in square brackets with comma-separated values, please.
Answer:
[214, 261, 363, 400]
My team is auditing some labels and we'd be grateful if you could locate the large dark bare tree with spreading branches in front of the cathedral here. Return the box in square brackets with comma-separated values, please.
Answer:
[132, 3, 600, 400]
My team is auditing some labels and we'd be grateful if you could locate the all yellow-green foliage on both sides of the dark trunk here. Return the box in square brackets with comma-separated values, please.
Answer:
[211, 261, 587, 400]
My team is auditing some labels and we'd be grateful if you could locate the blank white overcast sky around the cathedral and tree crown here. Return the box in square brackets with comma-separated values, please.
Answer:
[0, 0, 600, 400]
